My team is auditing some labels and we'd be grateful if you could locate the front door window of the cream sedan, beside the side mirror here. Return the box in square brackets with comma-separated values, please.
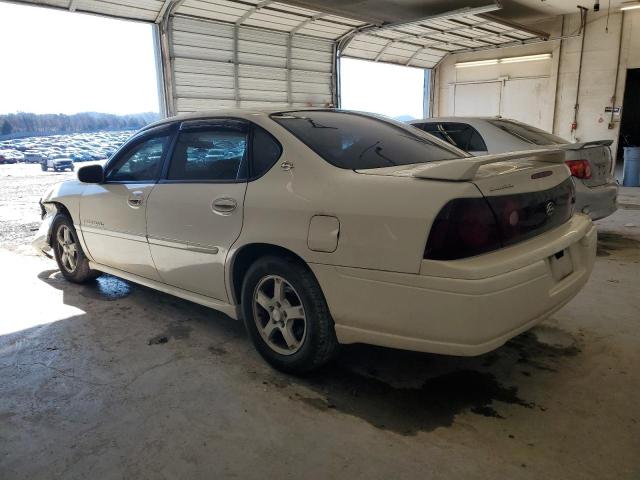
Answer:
[106, 135, 170, 182]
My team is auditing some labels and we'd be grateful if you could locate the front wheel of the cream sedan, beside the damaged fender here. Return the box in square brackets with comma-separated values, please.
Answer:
[51, 214, 101, 283]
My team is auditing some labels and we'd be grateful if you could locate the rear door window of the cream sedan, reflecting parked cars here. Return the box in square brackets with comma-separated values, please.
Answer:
[167, 127, 247, 181]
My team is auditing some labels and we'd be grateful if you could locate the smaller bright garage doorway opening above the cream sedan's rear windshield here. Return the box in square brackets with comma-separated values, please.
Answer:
[340, 58, 431, 121]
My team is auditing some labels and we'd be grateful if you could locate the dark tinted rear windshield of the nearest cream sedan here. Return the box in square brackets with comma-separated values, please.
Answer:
[271, 110, 466, 170]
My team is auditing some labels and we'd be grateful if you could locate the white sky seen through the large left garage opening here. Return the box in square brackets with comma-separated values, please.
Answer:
[0, 2, 158, 114]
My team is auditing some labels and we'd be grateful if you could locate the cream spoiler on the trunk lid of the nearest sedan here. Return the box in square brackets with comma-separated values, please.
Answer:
[398, 149, 565, 182]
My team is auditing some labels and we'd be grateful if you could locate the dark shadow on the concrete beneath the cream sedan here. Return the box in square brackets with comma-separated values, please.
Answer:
[39, 270, 581, 435]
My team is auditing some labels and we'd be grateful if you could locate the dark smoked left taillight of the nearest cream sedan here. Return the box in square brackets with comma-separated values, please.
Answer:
[424, 198, 501, 260]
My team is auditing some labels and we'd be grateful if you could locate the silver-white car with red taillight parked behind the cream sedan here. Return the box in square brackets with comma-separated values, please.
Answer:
[410, 117, 618, 220]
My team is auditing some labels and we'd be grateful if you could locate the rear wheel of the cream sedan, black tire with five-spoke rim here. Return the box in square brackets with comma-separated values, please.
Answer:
[241, 256, 338, 374]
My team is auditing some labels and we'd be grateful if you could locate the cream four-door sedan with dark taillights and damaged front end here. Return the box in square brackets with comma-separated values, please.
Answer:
[34, 110, 596, 372]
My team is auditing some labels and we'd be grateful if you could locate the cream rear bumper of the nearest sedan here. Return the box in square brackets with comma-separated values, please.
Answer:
[311, 215, 597, 355]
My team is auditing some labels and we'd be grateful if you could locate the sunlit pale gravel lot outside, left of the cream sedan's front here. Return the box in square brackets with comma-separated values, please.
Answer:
[0, 162, 97, 253]
